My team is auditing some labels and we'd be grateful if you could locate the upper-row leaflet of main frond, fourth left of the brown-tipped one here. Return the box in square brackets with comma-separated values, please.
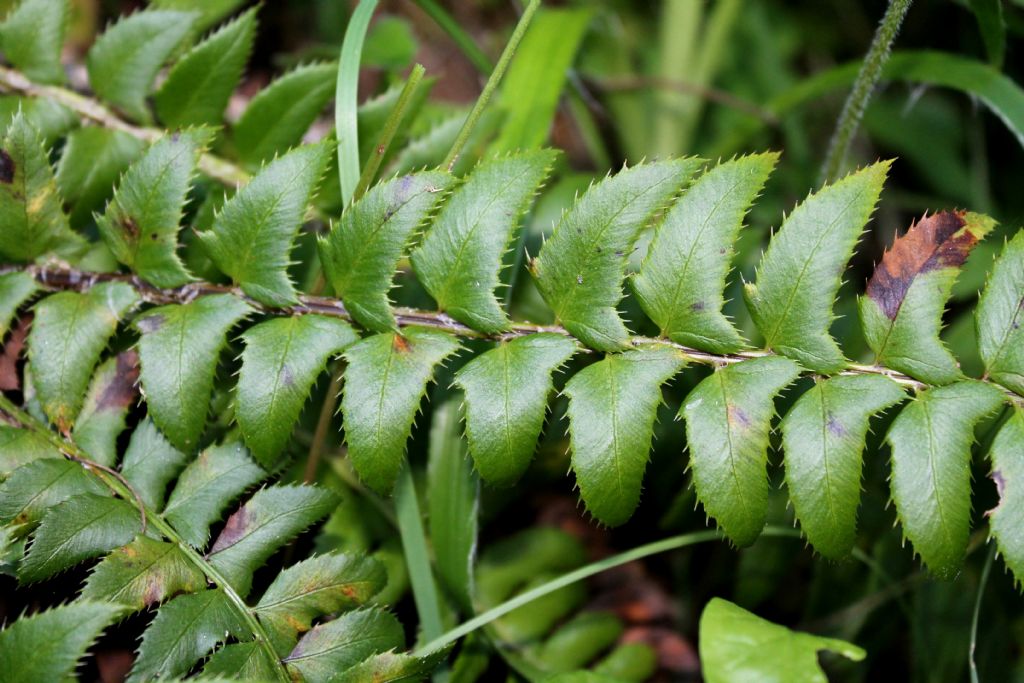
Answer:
[412, 150, 555, 333]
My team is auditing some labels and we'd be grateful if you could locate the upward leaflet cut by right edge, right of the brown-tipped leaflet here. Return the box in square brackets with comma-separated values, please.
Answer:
[977, 230, 1024, 396]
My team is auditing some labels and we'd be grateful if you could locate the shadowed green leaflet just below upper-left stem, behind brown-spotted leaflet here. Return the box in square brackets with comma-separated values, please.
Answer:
[56, 126, 145, 227]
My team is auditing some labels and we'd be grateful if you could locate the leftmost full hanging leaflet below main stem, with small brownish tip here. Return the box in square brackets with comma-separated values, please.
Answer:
[29, 283, 138, 431]
